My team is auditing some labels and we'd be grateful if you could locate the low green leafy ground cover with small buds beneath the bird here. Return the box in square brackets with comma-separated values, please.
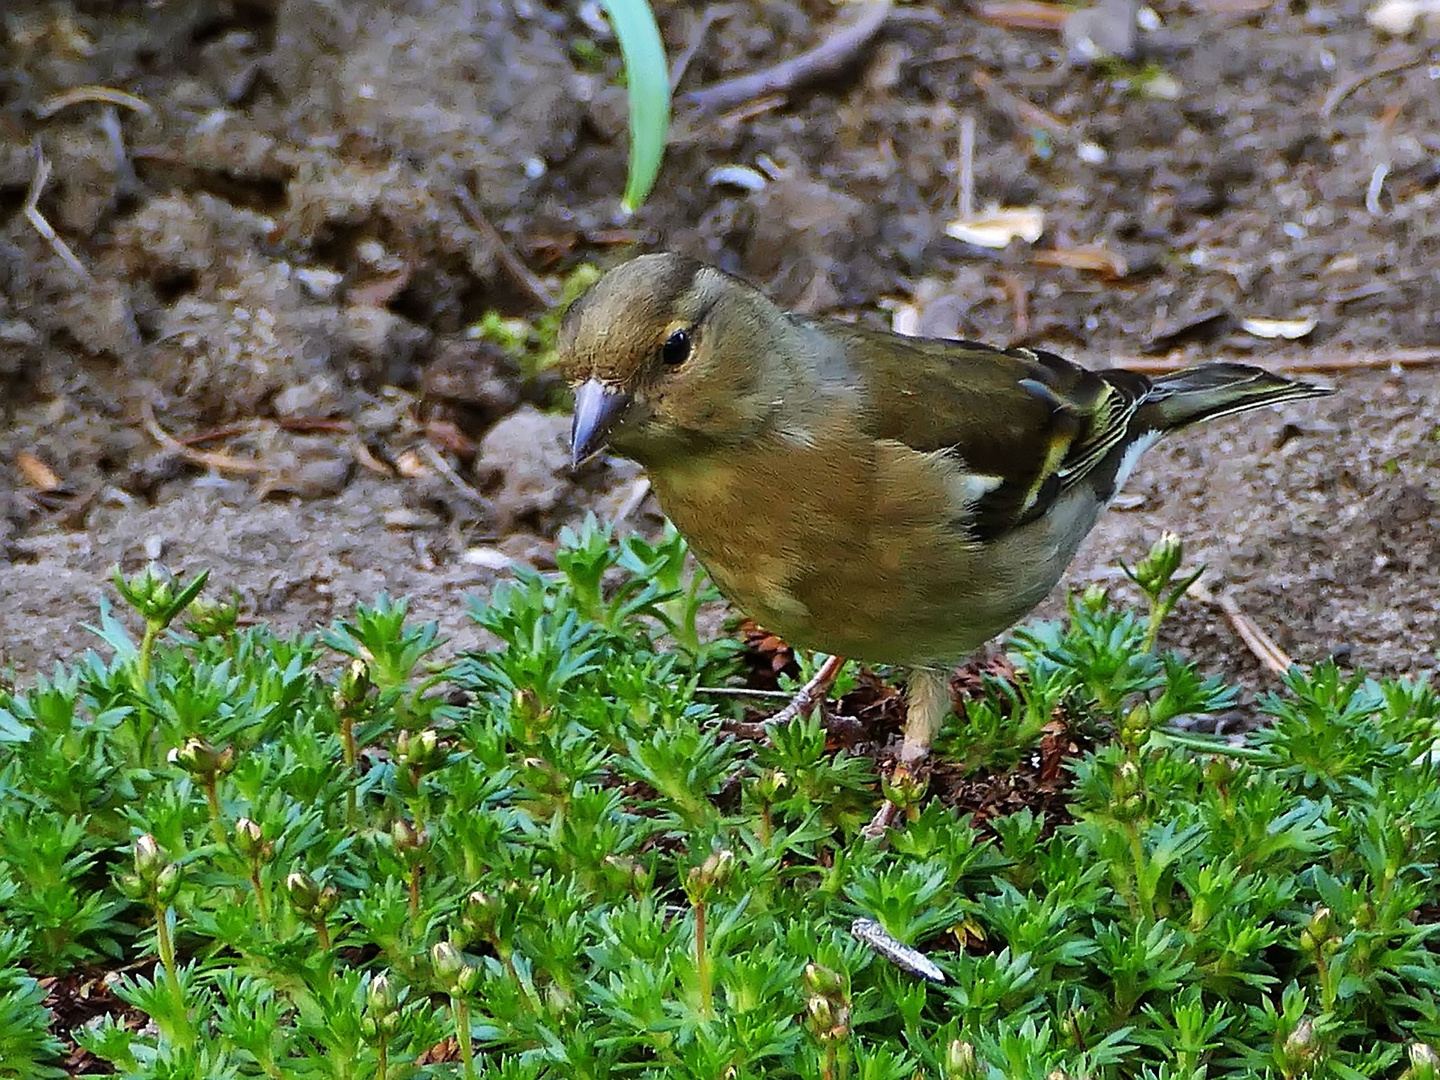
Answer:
[0, 523, 1440, 1080]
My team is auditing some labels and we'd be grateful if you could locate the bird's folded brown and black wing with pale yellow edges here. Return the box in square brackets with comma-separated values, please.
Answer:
[831, 327, 1152, 540]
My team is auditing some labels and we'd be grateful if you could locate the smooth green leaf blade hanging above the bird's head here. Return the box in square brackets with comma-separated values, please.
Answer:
[602, 0, 670, 213]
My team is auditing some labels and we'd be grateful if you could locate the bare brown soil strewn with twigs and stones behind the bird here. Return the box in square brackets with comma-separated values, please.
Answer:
[0, 0, 1440, 683]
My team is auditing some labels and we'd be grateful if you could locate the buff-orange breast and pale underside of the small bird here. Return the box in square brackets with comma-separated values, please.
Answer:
[651, 439, 1088, 665]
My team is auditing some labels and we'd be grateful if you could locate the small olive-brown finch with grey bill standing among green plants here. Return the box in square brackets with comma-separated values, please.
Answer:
[556, 252, 1333, 835]
